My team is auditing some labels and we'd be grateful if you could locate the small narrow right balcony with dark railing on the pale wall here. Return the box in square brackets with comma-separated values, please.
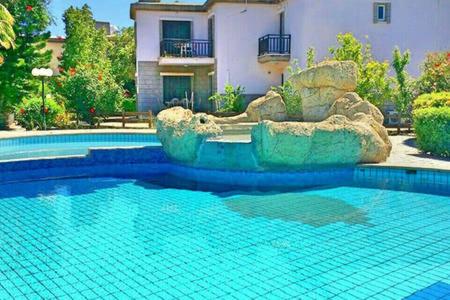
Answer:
[258, 34, 291, 63]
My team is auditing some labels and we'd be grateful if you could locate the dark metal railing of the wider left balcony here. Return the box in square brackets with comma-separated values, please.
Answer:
[160, 39, 213, 57]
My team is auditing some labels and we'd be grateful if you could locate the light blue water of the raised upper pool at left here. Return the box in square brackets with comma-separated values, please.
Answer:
[0, 133, 160, 160]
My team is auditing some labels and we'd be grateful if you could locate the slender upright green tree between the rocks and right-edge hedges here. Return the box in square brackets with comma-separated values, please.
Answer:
[392, 47, 413, 128]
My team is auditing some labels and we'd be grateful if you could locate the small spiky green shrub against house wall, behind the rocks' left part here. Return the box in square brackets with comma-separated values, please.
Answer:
[209, 84, 245, 112]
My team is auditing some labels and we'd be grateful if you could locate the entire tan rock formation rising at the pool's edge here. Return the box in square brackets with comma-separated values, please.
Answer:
[157, 62, 392, 170]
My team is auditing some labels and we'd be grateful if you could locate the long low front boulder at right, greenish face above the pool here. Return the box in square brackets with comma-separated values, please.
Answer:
[252, 114, 391, 169]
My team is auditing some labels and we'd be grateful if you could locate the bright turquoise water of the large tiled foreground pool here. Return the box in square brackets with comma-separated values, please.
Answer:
[0, 177, 450, 299]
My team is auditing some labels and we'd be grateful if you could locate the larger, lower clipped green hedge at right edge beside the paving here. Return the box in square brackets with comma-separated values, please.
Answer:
[413, 106, 450, 157]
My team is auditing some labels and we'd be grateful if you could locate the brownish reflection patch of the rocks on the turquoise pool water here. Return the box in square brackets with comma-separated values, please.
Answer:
[224, 193, 371, 227]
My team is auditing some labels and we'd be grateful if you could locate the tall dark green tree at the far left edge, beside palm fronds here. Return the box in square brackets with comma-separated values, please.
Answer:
[0, 0, 51, 113]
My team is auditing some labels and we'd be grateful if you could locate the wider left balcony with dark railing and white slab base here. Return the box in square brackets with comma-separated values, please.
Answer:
[159, 39, 214, 65]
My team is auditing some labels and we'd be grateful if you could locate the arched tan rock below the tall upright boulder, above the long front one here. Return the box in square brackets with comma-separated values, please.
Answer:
[328, 93, 384, 124]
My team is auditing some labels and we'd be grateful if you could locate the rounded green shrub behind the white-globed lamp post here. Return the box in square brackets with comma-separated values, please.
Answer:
[16, 97, 65, 130]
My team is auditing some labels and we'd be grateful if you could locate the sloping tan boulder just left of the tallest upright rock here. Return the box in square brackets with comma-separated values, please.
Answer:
[211, 91, 287, 124]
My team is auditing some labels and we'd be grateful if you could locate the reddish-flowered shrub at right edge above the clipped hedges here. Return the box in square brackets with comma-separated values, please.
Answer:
[417, 51, 450, 94]
